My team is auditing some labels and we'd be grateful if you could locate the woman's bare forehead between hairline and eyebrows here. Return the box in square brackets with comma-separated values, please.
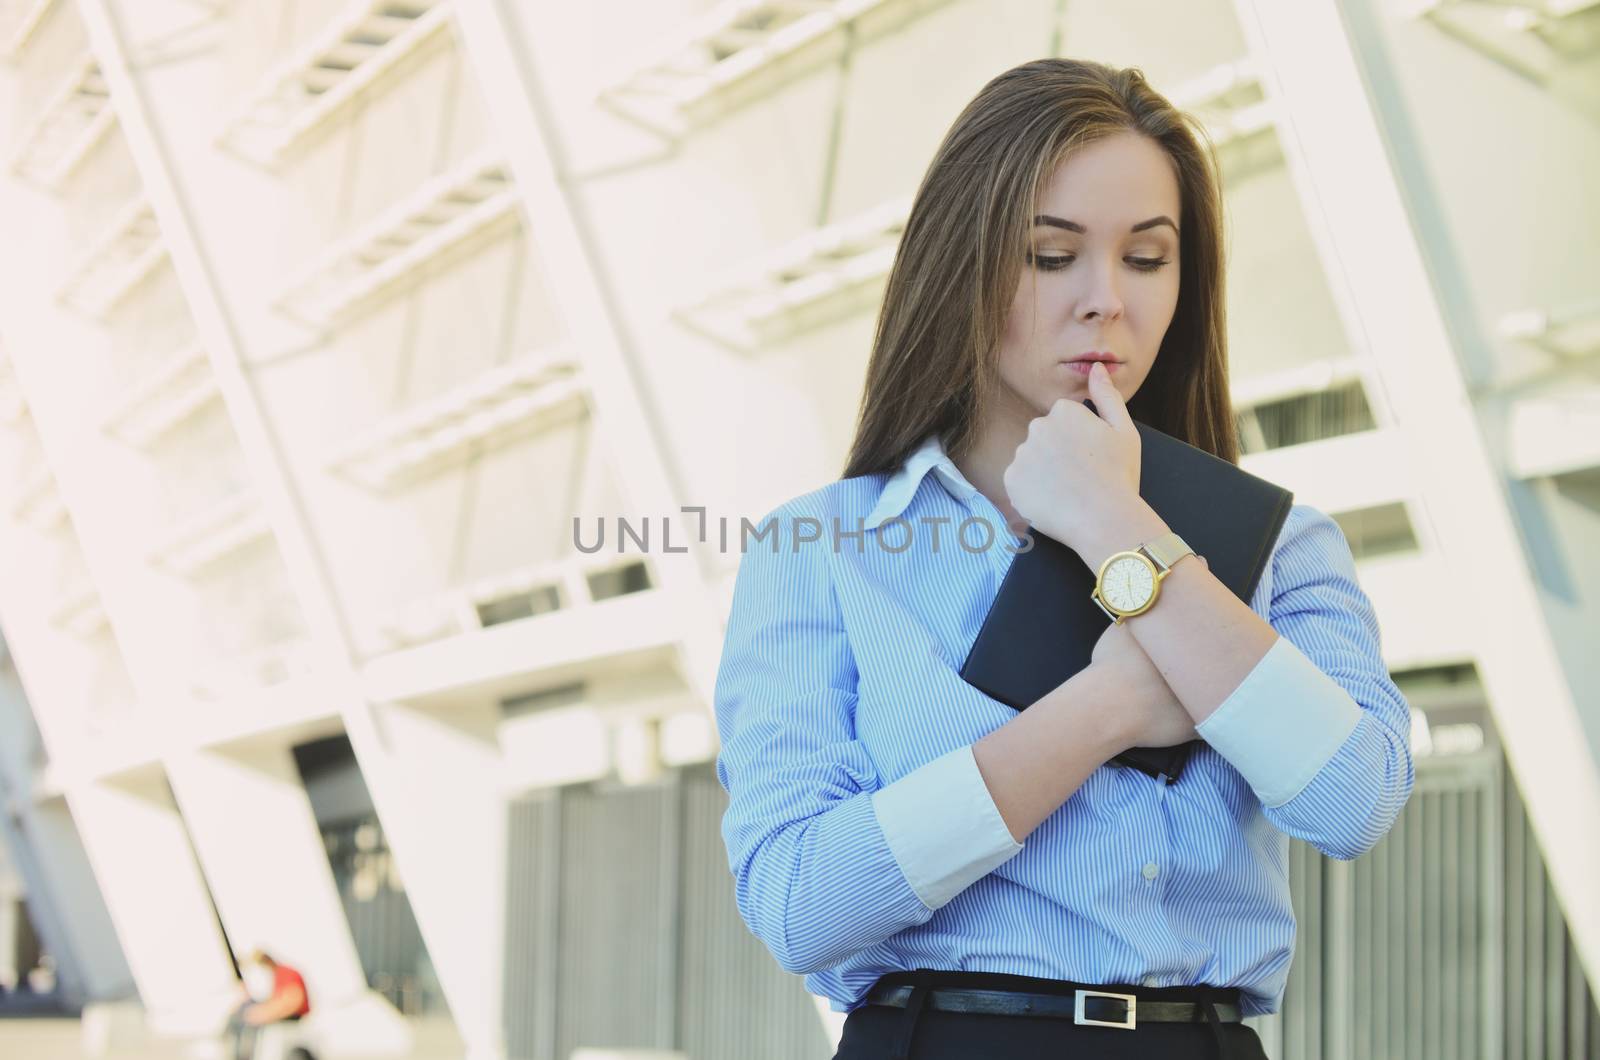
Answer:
[1038, 133, 1182, 225]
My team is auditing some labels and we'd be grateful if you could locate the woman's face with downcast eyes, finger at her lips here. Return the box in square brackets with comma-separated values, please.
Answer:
[1000, 133, 1182, 423]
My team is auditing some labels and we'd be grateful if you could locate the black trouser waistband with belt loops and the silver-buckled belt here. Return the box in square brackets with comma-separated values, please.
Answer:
[866, 969, 1243, 1060]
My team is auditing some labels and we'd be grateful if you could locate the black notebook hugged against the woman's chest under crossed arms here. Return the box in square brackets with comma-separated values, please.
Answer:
[962, 416, 1294, 783]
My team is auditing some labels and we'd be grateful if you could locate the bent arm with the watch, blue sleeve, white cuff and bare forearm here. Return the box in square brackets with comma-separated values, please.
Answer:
[1085, 504, 1414, 860]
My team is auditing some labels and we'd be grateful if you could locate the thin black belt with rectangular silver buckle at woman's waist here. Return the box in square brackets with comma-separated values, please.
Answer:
[867, 985, 1245, 1031]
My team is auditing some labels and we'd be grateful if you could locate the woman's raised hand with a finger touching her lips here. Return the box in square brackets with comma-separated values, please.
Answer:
[1003, 365, 1144, 552]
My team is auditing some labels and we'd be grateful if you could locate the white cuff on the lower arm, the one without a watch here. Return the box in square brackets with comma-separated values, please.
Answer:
[872, 745, 1022, 909]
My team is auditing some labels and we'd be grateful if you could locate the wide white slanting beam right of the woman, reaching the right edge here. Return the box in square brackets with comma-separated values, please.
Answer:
[1235, 0, 1600, 1005]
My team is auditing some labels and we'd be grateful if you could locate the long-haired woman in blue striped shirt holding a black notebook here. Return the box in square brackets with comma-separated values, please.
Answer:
[715, 59, 1413, 1060]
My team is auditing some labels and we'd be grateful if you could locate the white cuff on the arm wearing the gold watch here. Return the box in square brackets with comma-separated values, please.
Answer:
[1195, 636, 1362, 809]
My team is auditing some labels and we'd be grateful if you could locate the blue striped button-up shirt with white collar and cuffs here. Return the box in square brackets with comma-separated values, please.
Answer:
[714, 436, 1413, 1015]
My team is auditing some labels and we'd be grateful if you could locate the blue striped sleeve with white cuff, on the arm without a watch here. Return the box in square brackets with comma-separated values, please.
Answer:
[714, 509, 1022, 974]
